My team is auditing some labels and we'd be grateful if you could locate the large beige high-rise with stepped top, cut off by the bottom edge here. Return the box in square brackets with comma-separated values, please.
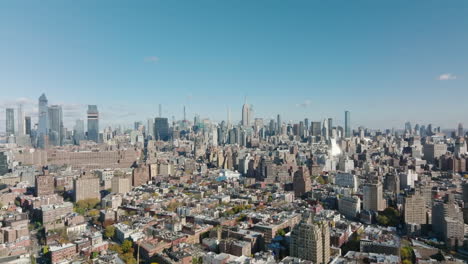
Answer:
[289, 215, 330, 264]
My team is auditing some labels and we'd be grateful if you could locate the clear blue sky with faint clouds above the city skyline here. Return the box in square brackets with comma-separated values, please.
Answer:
[0, 0, 468, 128]
